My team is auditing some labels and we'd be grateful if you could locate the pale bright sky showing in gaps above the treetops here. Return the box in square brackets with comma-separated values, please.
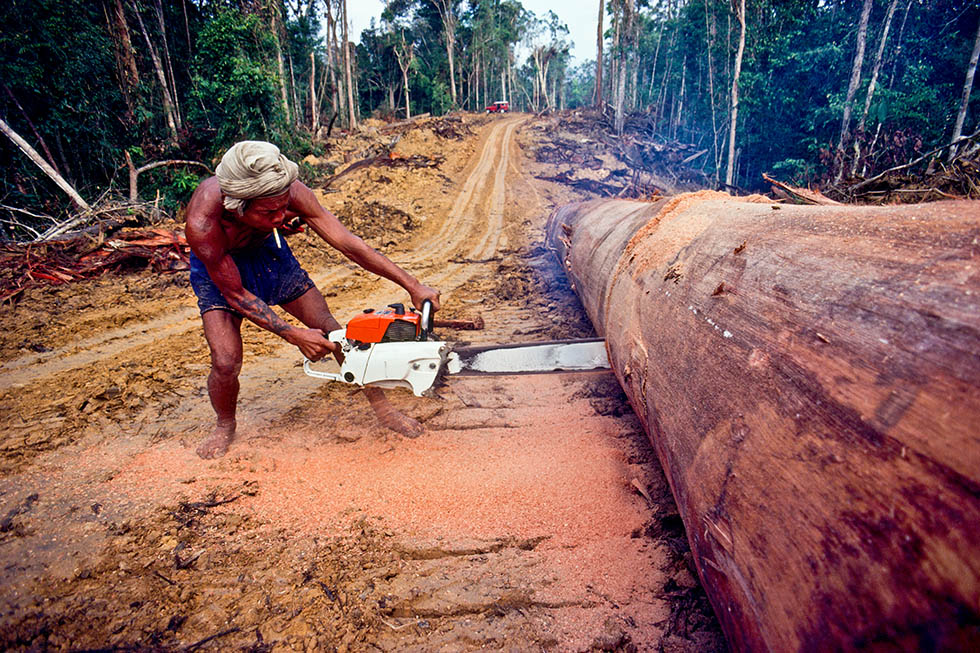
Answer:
[347, 0, 599, 65]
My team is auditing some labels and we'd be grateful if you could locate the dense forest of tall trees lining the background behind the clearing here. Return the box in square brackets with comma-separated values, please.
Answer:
[0, 0, 980, 240]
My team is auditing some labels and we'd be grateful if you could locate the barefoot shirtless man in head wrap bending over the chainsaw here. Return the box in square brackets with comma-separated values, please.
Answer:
[186, 141, 439, 458]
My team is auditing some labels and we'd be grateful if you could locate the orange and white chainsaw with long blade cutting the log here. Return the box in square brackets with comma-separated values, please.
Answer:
[303, 301, 609, 397]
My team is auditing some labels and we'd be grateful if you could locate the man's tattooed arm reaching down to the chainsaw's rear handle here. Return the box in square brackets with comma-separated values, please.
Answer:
[186, 181, 336, 360]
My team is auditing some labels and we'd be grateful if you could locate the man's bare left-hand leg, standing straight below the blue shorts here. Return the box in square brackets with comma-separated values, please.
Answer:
[197, 310, 242, 458]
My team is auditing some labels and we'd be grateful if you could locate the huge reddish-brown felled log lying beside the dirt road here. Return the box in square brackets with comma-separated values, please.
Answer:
[548, 192, 980, 651]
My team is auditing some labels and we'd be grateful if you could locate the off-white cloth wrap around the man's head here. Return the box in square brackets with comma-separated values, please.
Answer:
[215, 141, 299, 214]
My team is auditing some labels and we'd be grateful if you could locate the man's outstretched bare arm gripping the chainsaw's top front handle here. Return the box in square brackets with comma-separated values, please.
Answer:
[289, 181, 439, 311]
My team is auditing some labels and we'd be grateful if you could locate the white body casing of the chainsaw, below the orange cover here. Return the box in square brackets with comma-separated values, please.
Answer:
[303, 329, 450, 397]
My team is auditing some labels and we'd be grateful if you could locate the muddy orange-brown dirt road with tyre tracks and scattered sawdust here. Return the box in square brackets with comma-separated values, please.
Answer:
[0, 116, 723, 651]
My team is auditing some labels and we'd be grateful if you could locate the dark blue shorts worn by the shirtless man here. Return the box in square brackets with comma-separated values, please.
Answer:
[191, 234, 314, 317]
